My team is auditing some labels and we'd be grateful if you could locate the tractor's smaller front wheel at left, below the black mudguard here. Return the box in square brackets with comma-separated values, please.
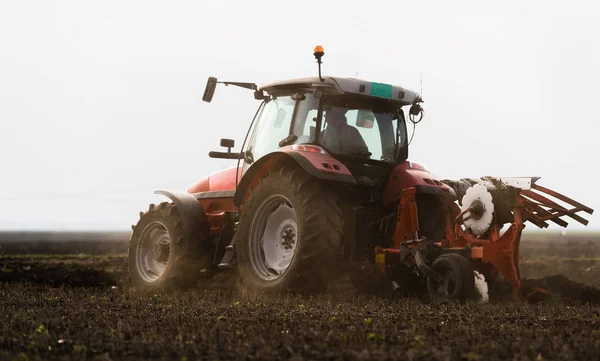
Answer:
[128, 202, 212, 289]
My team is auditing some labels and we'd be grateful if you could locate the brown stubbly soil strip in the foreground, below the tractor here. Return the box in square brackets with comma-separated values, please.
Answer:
[0, 284, 600, 360]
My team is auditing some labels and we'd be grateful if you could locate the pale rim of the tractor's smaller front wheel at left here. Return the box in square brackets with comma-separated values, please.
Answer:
[135, 221, 171, 283]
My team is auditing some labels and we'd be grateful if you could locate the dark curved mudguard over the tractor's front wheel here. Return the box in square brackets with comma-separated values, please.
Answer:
[154, 190, 210, 248]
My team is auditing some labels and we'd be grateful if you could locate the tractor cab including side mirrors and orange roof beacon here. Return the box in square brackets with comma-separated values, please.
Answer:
[204, 47, 422, 190]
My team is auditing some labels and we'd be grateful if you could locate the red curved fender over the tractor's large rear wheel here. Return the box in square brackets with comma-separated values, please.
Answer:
[233, 145, 356, 206]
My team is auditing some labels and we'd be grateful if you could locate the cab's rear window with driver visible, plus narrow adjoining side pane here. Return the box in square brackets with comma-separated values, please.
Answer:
[294, 95, 406, 162]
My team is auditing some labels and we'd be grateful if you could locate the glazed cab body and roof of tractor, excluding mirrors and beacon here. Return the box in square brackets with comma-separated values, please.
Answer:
[250, 77, 416, 163]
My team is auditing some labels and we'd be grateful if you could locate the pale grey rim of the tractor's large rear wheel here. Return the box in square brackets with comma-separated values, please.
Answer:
[249, 195, 299, 281]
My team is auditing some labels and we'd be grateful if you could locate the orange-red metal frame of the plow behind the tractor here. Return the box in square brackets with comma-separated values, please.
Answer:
[376, 184, 594, 299]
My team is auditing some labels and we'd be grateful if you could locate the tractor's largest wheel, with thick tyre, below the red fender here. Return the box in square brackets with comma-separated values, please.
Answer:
[237, 168, 342, 292]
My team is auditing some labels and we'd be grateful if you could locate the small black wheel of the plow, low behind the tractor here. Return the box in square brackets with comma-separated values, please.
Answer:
[427, 253, 475, 301]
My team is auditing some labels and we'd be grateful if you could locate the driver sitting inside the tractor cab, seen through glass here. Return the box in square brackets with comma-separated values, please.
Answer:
[321, 107, 370, 157]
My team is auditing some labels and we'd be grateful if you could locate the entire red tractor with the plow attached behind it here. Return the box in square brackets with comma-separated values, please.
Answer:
[129, 47, 593, 299]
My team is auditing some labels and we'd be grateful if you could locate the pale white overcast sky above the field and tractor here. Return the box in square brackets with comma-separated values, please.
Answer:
[0, 0, 600, 230]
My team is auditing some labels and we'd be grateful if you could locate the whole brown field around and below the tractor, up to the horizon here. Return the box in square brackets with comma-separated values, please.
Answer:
[0, 232, 600, 360]
